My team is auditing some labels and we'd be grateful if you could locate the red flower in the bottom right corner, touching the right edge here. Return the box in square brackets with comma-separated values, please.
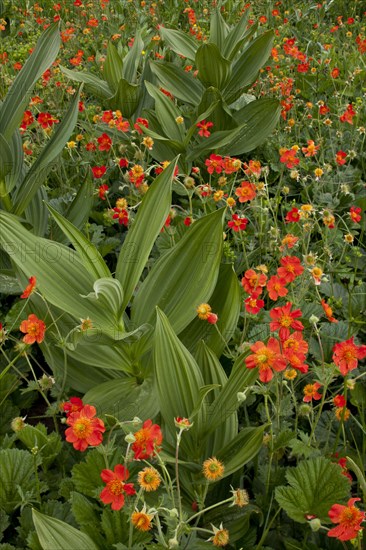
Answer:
[327, 498, 366, 541]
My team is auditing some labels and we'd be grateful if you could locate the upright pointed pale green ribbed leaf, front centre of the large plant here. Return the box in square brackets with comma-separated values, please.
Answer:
[153, 308, 204, 459]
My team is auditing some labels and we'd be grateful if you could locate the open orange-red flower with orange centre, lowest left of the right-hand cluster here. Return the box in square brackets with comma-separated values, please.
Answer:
[245, 338, 287, 382]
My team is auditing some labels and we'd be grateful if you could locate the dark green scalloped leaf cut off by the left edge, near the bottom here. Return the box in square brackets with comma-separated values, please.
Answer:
[0, 449, 34, 514]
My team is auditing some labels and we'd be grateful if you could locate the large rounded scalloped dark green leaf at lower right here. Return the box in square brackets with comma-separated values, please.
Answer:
[275, 457, 350, 523]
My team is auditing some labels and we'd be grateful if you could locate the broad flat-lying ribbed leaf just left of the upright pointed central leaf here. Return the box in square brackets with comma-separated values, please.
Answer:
[84, 377, 159, 421]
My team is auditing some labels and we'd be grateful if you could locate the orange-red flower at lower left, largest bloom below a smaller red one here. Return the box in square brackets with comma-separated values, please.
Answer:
[65, 405, 105, 452]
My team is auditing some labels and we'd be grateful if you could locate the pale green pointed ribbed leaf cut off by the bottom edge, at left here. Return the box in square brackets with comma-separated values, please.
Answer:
[32, 508, 98, 550]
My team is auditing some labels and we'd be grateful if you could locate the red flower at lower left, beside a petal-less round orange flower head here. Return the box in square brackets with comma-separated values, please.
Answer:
[99, 464, 136, 510]
